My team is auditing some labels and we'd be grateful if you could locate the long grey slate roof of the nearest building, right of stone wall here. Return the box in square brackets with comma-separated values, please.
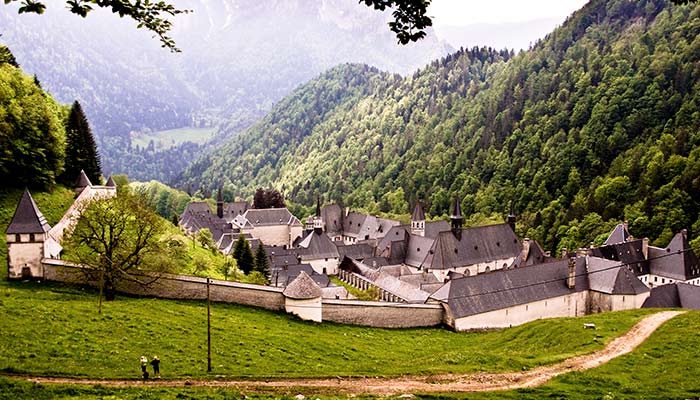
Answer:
[430, 256, 588, 318]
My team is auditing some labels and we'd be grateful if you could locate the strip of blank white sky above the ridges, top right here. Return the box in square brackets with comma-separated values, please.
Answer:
[428, 0, 586, 26]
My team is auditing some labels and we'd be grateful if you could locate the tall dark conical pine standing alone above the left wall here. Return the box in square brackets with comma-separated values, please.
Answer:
[62, 101, 102, 185]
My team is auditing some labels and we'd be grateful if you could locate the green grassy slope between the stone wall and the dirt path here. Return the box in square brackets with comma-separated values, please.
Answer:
[0, 283, 648, 379]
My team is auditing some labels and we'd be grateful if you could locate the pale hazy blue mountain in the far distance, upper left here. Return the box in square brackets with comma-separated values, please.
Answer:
[0, 0, 450, 180]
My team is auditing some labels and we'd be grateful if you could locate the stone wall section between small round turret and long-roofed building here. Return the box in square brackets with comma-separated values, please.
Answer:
[323, 300, 444, 328]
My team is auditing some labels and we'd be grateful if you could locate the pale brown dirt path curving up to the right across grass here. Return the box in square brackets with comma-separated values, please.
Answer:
[16, 311, 683, 395]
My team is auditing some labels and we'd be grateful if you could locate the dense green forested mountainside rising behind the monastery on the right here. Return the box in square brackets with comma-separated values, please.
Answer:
[179, 0, 700, 255]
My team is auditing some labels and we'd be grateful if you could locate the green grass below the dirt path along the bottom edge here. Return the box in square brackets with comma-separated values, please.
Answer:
[0, 312, 700, 400]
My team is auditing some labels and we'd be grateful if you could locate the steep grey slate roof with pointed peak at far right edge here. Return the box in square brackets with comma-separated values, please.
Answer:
[649, 232, 700, 281]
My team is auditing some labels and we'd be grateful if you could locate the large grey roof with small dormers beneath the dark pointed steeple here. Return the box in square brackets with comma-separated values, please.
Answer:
[418, 224, 522, 269]
